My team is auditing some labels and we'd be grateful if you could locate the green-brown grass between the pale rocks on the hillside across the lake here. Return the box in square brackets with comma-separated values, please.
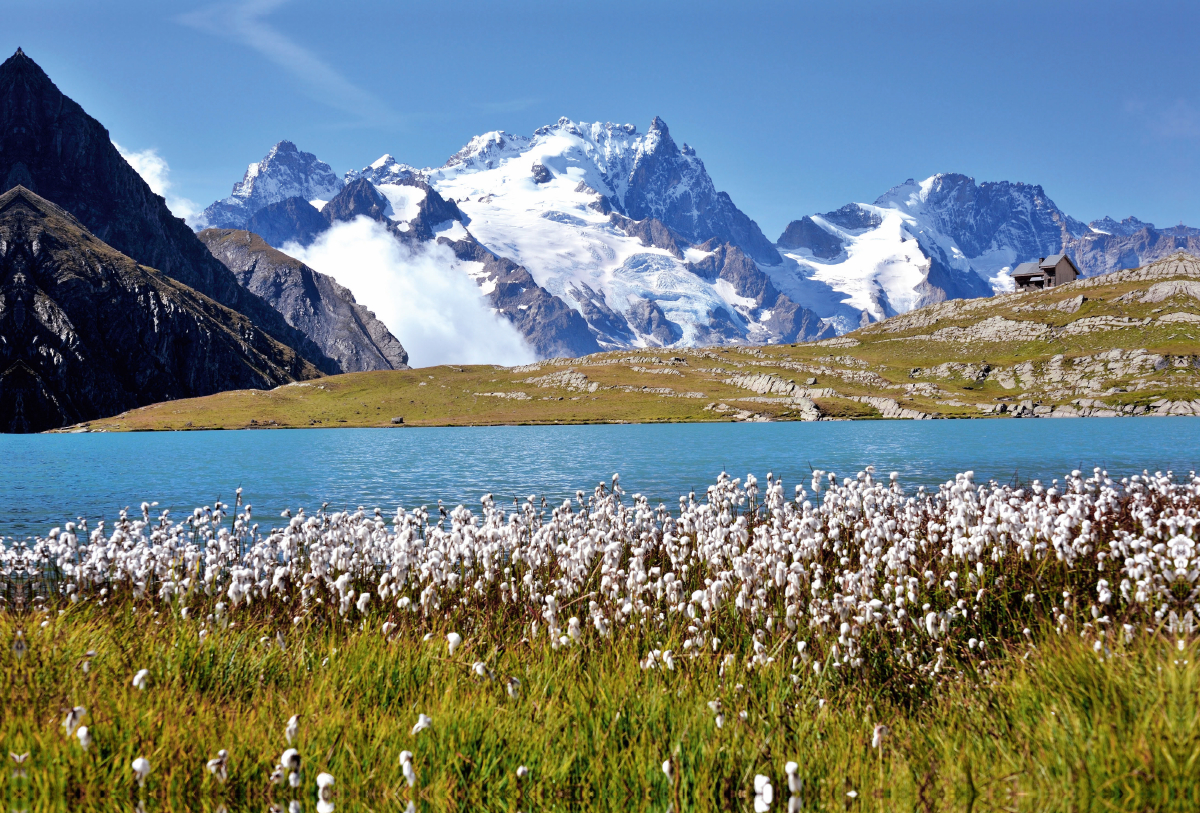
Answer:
[70, 256, 1200, 432]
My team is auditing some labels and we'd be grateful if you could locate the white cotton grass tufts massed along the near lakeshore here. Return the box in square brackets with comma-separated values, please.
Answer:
[12, 469, 1200, 733]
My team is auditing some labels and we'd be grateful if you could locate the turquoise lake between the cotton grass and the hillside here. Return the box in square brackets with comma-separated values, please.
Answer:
[0, 417, 1200, 537]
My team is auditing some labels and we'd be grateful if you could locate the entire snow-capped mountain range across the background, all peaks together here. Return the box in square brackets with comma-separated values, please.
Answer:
[196, 128, 1200, 355]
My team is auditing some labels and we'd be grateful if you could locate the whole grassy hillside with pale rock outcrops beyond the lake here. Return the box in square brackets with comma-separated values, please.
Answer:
[74, 254, 1200, 432]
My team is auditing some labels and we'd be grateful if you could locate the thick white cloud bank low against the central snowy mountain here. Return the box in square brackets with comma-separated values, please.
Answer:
[283, 217, 536, 367]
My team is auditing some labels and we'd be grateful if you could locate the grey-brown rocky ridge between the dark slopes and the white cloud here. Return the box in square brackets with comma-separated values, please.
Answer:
[198, 229, 408, 373]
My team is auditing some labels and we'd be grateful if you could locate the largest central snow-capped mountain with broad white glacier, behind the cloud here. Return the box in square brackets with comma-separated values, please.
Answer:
[201, 119, 832, 355]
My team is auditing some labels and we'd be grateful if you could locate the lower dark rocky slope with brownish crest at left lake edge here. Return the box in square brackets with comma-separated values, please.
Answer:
[0, 186, 320, 432]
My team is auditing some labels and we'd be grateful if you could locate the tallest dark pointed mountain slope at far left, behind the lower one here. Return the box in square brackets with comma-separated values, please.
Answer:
[0, 49, 337, 373]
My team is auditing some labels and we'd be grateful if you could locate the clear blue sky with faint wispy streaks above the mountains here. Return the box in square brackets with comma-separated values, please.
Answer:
[9, 0, 1200, 239]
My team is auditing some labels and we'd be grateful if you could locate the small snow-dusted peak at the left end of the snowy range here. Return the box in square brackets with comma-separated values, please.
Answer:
[192, 141, 344, 230]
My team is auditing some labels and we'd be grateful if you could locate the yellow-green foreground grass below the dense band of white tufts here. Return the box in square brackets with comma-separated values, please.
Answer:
[0, 609, 1200, 811]
